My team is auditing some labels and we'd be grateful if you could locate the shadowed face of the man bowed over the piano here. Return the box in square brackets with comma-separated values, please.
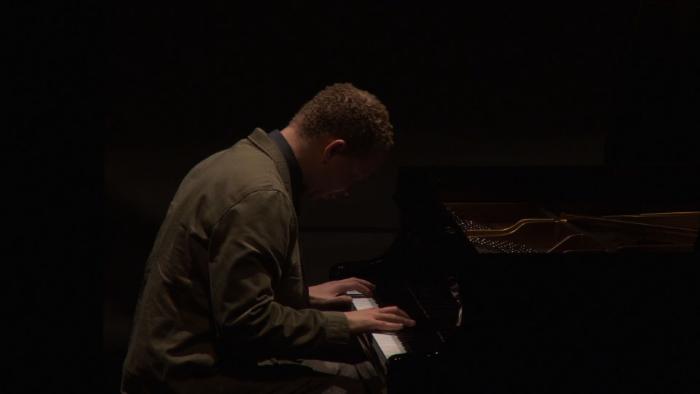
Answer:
[311, 153, 385, 200]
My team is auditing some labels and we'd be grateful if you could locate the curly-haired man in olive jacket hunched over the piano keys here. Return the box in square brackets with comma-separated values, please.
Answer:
[121, 83, 415, 393]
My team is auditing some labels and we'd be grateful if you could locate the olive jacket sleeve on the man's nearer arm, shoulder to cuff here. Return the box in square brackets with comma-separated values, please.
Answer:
[209, 190, 350, 359]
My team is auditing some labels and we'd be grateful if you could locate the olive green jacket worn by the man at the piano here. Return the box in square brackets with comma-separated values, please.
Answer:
[122, 129, 350, 392]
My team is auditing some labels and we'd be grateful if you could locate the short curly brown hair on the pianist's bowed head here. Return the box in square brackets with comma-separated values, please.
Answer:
[290, 83, 394, 155]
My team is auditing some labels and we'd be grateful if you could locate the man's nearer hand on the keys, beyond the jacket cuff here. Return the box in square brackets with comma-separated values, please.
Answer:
[344, 306, 416, 334]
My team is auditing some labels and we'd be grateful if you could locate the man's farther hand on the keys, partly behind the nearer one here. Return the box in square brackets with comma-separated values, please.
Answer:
[309, 277, 375, 309]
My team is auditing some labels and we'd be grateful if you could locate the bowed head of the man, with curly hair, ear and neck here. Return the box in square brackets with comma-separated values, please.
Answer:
[282, 83, 394, 198]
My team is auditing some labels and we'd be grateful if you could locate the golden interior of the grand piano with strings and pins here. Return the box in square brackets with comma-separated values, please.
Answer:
[443, 202, 700, 253]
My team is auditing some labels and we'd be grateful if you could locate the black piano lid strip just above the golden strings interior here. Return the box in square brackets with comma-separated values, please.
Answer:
[395, 165, 700, 215]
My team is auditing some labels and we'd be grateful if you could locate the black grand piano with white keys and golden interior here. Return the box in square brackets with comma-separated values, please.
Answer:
[330, 166, 700, 393]
